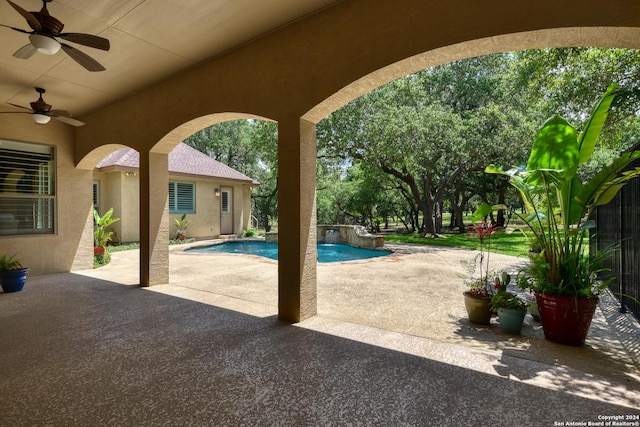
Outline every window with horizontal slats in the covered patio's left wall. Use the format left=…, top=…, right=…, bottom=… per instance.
left=0, top=139, right=56, bottom=236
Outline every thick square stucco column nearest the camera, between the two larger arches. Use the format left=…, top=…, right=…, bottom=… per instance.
left=278, top=117, right=318, bottom=322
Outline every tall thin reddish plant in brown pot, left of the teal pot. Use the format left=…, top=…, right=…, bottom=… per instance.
left=463, top=203, right=500, bottom=325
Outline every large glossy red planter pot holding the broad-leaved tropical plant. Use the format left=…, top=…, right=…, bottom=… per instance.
left=536, top=294, right=598, bottom=346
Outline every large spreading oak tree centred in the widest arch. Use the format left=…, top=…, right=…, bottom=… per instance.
left=318, top=54, right=533, bottom=235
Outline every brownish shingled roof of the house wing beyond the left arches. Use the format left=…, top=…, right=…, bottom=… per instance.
left=96, top=142, right=258, bottom=185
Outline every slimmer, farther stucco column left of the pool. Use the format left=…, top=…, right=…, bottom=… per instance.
left=139, top=151, right=169, bottom=286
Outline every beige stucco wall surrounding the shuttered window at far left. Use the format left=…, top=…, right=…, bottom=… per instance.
left=0, top=114, right=93, bottom=275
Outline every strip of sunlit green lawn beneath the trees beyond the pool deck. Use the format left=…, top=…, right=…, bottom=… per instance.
left=384, top=232, right=529, bottom=256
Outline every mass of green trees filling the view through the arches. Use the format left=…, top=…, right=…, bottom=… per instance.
left=185, top=48, right=640, bottom=236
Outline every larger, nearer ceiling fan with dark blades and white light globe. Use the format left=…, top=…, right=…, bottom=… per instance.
left=0, top=0, right=110, bottom=71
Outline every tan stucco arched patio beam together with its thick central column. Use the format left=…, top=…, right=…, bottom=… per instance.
left=67, top=0, right=640, bottom=321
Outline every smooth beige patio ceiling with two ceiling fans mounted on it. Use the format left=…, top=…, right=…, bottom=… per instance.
left=0, top=0, right=339, bottom=117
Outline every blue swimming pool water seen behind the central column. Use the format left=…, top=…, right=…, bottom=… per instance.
left=188, top=241, right=391, bottom=262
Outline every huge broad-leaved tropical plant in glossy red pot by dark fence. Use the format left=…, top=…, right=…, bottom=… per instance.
left=485, top=85, right=640, bottom=345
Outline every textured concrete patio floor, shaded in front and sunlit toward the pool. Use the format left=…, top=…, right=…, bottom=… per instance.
left=0, top=242, right=640, bottom=426
